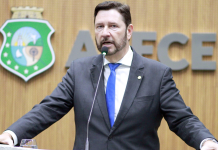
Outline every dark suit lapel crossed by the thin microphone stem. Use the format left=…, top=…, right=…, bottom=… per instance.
left=90, top=55, right=110, bottom=129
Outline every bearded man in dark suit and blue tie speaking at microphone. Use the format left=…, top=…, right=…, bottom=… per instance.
left=0, top=2, right=218, bottom=150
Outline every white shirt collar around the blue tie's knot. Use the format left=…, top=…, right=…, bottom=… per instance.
left=104, top=47, right=133, bottom=66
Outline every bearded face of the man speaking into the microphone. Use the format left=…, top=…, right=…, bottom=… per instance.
left=95, top=9, right=128, bottom=56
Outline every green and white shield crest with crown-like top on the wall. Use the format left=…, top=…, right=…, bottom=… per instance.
left=0, top=7, right=55, bottom=82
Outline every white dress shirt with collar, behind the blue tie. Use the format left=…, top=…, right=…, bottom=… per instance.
left=104, top=47, right=133, bottom=122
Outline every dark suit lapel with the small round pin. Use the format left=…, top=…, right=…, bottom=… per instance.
left=110, top=50, right=144, bottom=134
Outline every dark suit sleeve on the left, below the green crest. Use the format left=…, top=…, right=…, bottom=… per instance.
left=7, top=63, right=74, bottom=143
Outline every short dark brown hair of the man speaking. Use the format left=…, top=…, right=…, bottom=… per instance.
left=94, top=1, right=132, bottom=27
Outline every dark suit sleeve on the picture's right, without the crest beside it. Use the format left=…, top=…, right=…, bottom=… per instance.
left=160, top=68, right=215, bottom=149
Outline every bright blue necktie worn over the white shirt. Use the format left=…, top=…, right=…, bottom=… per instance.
left=106, top=63, right=120, bottom=127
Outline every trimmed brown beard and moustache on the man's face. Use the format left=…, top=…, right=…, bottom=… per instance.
left=95, top=32, right=127, bottom=56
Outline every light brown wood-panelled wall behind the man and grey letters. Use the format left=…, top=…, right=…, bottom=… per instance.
left=0, top=0, right=218, bottom=150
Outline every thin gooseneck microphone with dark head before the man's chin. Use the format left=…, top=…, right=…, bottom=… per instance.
left=85, top=46, right=108, bottom=150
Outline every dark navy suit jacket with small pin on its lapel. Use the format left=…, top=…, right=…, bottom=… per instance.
left=8, top=50, right=214, bottom=150
